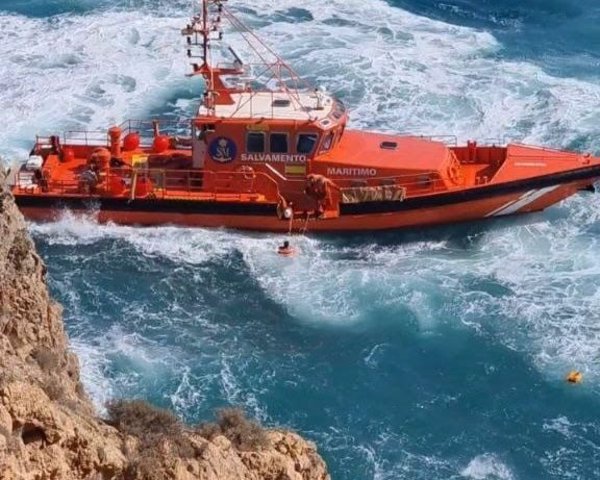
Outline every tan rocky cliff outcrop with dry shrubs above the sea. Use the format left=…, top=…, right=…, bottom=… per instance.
left=0, top=167, right=329, bottom=480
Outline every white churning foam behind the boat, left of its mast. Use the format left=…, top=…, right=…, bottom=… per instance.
left=0, top=7, right=189, bottom=159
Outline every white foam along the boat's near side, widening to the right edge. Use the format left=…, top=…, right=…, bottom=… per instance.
left=31, top=196, right=600, bottom=392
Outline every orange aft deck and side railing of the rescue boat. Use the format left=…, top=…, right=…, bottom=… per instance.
left=13, top=147, right=278, bottom=203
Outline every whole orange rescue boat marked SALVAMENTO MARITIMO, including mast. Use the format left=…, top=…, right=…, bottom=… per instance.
left=4, top=0, right=600, bottom=232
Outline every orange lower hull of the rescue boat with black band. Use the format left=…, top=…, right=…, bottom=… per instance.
left=12, top=166, right=600, bottom=232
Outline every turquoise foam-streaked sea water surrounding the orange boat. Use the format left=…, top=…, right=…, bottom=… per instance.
left=0, top=0, right=600, bottom=480
